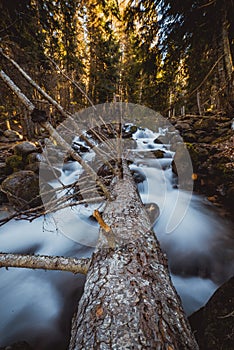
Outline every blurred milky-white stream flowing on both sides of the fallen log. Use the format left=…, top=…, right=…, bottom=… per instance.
left=0, top=124, right=234, bottom=350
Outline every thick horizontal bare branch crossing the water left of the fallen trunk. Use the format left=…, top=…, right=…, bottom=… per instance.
left=0, top=253, right=90, bottom=274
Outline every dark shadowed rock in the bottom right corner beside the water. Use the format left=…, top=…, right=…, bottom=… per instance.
left=189, top=277, right=234, bottom=350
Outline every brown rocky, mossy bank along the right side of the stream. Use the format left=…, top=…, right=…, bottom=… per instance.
left=171, top=114, right=234, bottom=218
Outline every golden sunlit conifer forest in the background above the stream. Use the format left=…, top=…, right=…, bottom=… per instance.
left=0, top=0, right=234, bottom=120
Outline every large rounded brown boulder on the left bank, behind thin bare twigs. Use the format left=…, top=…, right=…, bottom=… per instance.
left=1, top=170, right=51, bottom=210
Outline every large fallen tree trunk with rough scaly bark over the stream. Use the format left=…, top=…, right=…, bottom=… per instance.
left=69, top=164, right=198, bottom=350
